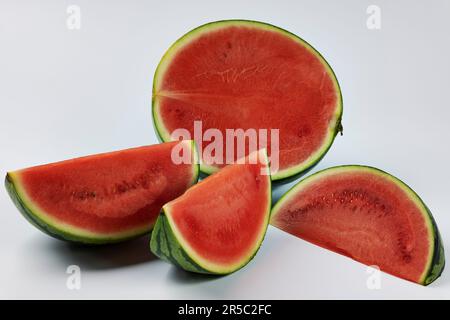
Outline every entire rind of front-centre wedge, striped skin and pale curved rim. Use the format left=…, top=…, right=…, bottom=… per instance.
left=150, top=152, right=272, bottom=275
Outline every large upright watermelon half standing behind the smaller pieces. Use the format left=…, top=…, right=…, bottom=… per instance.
left=152, top=20, right=342, bottom=180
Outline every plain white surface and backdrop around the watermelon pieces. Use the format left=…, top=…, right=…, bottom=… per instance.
left=0, top=0, right=450, bottom=299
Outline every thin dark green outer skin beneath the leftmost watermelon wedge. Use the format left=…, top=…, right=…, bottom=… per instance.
left=5, top=174, right=151, bottom=245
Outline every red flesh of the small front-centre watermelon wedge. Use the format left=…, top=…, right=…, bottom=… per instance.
left=168, top=152, right=270, bottom=264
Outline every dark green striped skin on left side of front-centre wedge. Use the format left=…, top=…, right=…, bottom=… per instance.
left=150, top=212, right=209, bottom=274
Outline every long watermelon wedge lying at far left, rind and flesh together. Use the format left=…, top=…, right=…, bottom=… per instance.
left=5, top=140, right=198, bottom=244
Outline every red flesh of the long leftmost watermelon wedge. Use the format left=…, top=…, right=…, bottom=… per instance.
left=18, top=142, right=194, bottom=233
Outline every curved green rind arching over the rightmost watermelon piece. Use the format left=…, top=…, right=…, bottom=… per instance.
left=271, top=165, right=445, bottom=286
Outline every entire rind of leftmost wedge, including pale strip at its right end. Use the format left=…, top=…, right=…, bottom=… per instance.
left=5, top=141, right=200, bottom=245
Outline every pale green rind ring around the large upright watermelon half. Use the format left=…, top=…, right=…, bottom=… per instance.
left=152, top=19, right=343, bottom=183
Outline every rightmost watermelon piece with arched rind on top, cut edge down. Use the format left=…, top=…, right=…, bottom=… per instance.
left=271, top=166, right=445, bottom=285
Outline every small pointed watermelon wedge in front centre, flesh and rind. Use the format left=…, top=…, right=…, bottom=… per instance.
left=150, top=150, right=272, bottom=274
